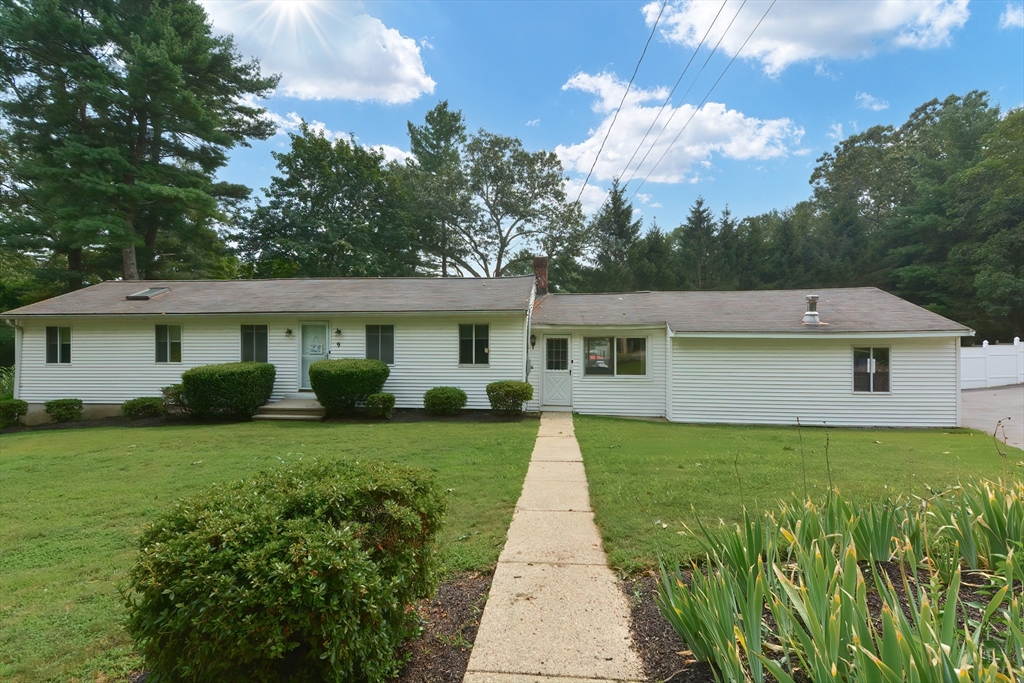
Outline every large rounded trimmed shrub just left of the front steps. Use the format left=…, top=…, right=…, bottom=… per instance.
left=181, top=361, right=276, bottom=418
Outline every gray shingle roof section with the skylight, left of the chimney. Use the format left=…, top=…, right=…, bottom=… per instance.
left=3, top=275, right=534, bottom=317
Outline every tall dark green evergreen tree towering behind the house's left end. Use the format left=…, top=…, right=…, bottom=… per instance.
left=0, top=0, right=276, bottom=288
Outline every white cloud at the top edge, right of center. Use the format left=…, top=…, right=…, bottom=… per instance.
left=643, top=0, right=970, bottom=76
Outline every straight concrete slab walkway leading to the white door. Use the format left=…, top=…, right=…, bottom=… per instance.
left=463, top=413, right=644, bottom=683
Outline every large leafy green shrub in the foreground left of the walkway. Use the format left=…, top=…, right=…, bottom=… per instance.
left=122, top=460, right=445, bottom=683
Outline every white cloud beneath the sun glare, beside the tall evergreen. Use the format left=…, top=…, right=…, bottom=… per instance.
left=203, top=0, right=435, bottom=104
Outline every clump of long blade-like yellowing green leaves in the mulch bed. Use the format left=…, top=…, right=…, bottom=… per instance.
left=658, top=481, right=1024, bottom=683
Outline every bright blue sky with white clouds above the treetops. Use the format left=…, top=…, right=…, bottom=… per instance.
left=203, top=0, right=1024, bottom=228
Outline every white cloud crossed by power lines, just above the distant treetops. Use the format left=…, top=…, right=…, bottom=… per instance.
left=555, top=74, right=804, bottom=183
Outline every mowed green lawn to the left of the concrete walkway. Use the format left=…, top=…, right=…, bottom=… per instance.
left=0, top=419, right=538, bottom=682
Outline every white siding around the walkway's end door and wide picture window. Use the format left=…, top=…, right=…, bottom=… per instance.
left=527, top=328, right=666, bottom=417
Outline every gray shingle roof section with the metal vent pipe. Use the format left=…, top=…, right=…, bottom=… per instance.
left=534, top=287, right=971, bottom=334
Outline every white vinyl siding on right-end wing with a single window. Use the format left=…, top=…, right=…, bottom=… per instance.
left=672, top=337, right=959, bottom=427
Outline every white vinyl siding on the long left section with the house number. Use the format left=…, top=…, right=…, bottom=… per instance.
left=18, top=312, right=526, bottom=409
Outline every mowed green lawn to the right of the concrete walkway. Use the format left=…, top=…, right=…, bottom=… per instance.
left=575, top=416, right=1024, bottom=572
